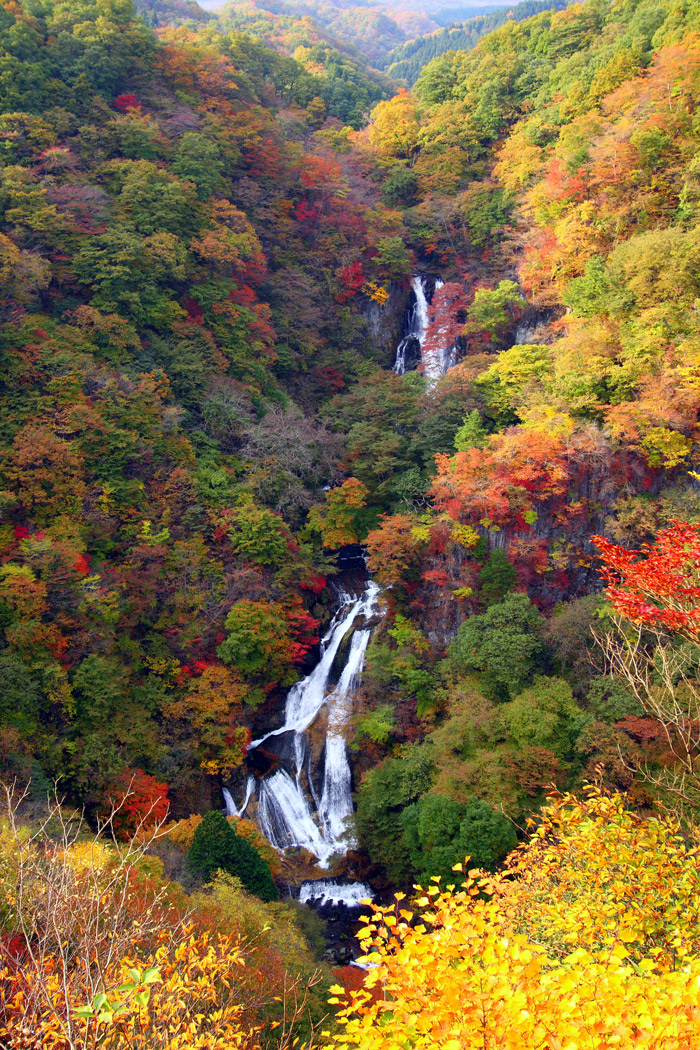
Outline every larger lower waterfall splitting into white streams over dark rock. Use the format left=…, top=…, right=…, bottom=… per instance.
left=232, top=581, right=379, bottom=867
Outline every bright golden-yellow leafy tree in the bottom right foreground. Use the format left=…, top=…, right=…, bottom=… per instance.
left=327, top=789, right=700, bottom=1050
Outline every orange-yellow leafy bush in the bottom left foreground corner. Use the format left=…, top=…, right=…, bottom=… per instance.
left=0, top=930, right=257, bottom=1050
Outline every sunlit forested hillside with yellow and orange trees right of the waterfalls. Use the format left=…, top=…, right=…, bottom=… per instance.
left=345, top=2, right=700, bottom=882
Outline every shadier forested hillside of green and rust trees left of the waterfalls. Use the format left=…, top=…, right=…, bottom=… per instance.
left=0, top=3, right=409, bottom=815
